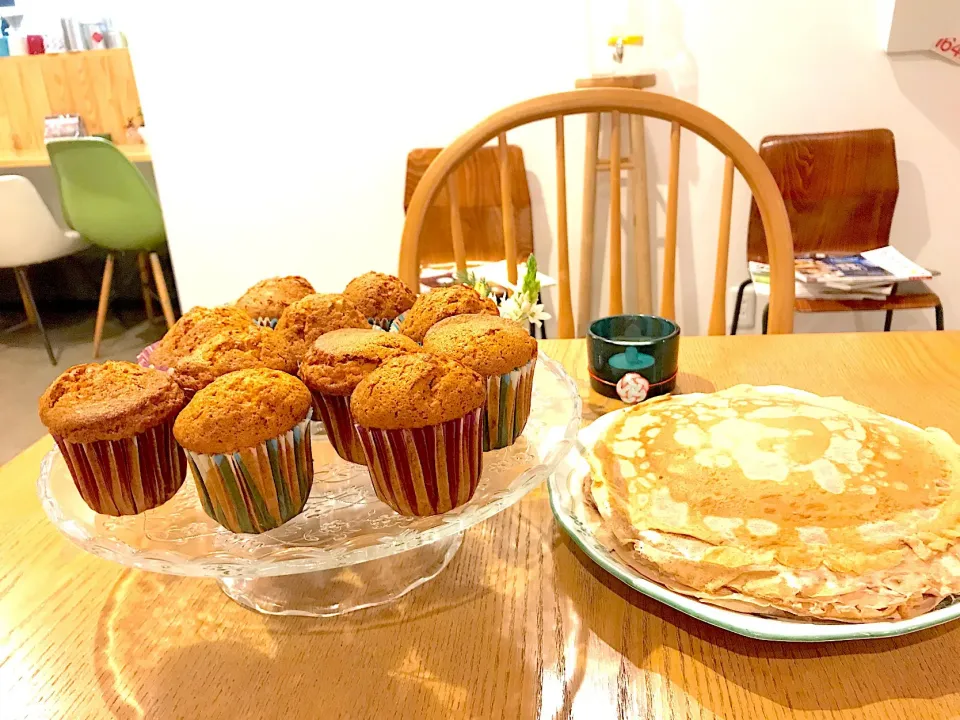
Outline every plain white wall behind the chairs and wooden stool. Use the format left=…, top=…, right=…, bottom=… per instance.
left=127, top=0, right=960, bottom=334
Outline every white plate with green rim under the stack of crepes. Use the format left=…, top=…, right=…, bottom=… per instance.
left=548, top=387, right=960, bottom=642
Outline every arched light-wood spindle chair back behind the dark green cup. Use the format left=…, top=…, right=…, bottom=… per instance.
left=400, top=88, right=794, bottom=337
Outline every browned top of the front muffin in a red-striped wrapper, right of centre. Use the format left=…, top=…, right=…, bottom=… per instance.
left=350, top=352, right=486, bottom=430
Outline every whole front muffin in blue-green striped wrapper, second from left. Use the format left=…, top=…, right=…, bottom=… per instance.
left=173, top=368, right=313, bottom=533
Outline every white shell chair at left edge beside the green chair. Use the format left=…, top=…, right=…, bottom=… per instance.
left=0, top=175, right=90, bottom=365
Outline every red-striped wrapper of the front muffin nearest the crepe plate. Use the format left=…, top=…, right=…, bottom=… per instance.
left=356, top=408, right=483, bottom=516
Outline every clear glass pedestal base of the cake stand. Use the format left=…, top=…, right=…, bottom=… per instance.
left=217, top=533, right=463, bottom=617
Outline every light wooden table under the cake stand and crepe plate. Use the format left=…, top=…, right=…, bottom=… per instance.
left=0, top=332, right=960, bottom=720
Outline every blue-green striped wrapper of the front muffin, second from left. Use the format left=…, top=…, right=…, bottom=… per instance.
left=187, top=413, right=313, bottom=533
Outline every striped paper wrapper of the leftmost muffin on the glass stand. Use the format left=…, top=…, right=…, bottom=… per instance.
left=53, top=420, right=187, bottom=516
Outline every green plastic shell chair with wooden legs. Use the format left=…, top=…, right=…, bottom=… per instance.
left=47, top=137, right=174, bottom=357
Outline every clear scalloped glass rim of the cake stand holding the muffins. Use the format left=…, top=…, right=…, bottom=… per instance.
left=37, top=351, right=582, bottom=577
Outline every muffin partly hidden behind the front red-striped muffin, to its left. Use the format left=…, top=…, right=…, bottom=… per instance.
left=300, top=326, right=420, bottom=465
